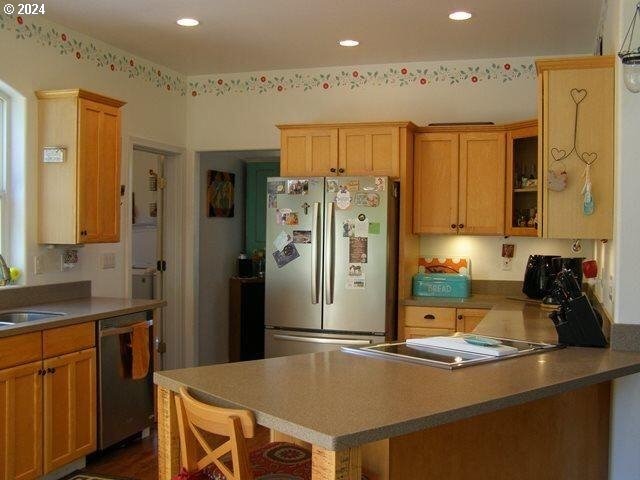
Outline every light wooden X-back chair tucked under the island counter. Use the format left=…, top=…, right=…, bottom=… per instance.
left=174, top=387, right=374, bottom=480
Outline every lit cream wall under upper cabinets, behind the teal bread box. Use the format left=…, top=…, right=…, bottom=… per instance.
left=416, top=235, right=593, bottom=281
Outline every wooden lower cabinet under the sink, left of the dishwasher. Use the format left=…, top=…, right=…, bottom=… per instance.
left=0, top=323, right=97, bottom=480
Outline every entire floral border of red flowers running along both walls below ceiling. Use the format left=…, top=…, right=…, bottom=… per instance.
left=0, top=13, right=536, bottom=97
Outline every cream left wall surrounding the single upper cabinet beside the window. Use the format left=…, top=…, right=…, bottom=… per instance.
left=0, top=15, right=186, bottom=296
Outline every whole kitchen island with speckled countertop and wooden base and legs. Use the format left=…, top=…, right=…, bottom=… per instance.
left=155, top=302, right=640, bottom=480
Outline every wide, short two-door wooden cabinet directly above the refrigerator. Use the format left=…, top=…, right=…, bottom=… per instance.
left=278, top=122, right=413, bottom=178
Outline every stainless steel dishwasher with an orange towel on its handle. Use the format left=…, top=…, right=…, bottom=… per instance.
left=97, top=311, right=154, bottom=450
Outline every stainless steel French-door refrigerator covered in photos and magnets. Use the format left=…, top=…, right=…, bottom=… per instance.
left=265, top=177, right=398, bottom=357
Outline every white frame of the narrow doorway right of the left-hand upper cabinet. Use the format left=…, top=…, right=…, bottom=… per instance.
left=122, top=136, right=197, bottom=368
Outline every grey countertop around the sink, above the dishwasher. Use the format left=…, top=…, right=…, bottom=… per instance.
left=0, top=297, right=167, bottom=338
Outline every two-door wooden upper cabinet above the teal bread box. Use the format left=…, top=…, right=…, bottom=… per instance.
left=413, top=132, right=505, bottom=235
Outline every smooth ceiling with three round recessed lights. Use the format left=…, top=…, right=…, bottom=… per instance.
left=47, top=0, right=603, bottom=75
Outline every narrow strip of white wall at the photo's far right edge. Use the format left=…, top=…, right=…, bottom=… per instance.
left=605, top=0, right=640, bottom=480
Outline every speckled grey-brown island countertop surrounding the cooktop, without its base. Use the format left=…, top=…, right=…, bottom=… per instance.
left=154, top=297, right=640, bottom=450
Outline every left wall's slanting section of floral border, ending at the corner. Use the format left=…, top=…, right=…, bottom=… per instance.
left=0, top=13, right=187, bottom=95
